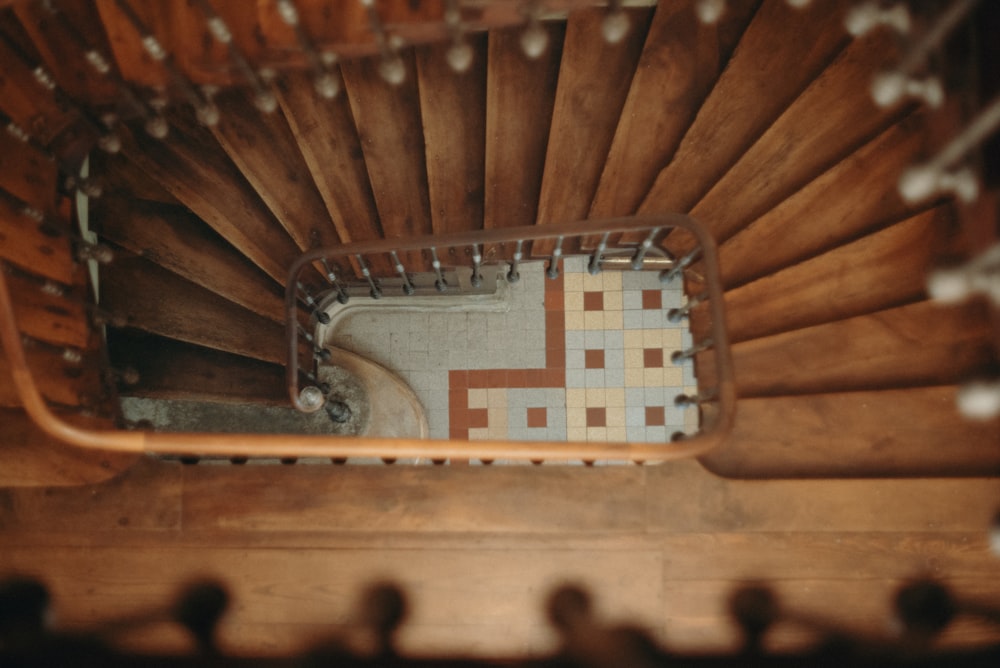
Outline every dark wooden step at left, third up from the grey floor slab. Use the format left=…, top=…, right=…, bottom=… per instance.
left=91, top=195, right=285, bottom=322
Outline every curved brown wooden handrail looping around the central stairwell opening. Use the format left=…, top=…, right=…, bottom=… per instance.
left=0, top=214, right=736, bottom=463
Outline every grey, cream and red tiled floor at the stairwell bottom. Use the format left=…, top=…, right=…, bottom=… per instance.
left=327, top=258, right=697, bottom=442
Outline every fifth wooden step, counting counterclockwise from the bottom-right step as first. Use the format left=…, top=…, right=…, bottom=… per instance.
left=677, top=33, right=905, bottom=252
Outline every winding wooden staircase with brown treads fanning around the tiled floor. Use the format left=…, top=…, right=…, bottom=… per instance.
left=0, top=0, right=1000, bottom=484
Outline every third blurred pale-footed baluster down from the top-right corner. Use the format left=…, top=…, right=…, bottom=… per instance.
left=899, top=97, right=1000, bottom=204
